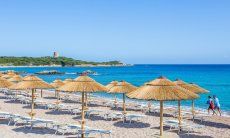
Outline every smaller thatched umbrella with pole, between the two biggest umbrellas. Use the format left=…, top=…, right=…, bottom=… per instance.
left=109, top=81, right=137, bottom=115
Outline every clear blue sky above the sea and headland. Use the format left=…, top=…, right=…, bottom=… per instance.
left=0, top=0, right=230, bottom=64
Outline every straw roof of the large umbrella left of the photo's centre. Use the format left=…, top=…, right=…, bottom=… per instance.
left=57, top=76, right=107, bottom=92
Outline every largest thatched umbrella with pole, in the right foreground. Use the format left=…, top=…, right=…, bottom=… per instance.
left=127, top=77, right=198, bottom=136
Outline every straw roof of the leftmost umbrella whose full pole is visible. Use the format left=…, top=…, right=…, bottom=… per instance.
left=10, top=75, right=53, bottom=89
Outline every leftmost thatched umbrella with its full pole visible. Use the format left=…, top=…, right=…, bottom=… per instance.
left=10, top=75, right=53, bottom=119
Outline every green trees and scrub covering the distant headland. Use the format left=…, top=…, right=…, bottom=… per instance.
left=0, top=56, right=123, bottom=66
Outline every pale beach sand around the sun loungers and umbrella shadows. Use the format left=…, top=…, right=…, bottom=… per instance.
left=0, top=91, right=230, bottom=138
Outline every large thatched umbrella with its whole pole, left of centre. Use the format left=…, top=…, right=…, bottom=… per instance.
left=57, top=76, right=107, bottom=137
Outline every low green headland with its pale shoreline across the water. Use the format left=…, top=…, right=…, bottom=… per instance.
left=0, top=56, right=131, bottom=68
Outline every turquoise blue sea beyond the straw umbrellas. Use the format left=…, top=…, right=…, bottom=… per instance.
left=0, top=65, right=230, bottom=114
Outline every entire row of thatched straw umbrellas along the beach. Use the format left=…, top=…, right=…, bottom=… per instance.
left=0, top=73, right=208, bottom=137
